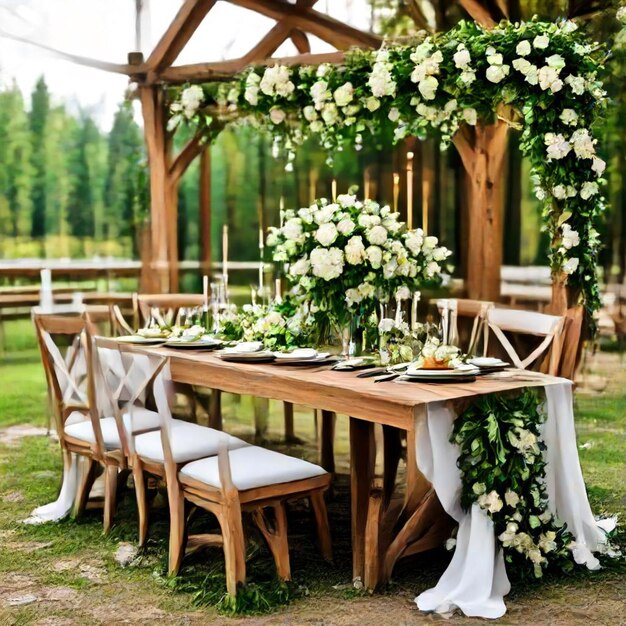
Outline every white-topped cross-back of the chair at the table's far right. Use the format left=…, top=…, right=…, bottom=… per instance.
left=487, top=307, right=565, bottom=376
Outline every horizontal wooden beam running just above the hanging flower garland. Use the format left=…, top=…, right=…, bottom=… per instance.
left=158, top=51, right=345, bottom=85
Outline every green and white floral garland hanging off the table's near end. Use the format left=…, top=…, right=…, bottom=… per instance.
left=450, top=389, right=574, bottom=578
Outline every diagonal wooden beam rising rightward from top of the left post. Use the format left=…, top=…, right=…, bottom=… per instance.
left=146, top=0, right=217, bottom=74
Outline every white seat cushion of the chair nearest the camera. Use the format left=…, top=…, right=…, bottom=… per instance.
left=178, top=446, right=326, bottom=491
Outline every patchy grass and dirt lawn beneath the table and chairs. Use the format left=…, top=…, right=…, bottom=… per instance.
left=0, top=323, right=626, bottom=626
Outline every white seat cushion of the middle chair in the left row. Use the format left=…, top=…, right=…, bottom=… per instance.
left=135, top=420, right=248, bottom=463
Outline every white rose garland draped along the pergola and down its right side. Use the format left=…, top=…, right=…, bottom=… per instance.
left=170, top=20, right=606, bottom=322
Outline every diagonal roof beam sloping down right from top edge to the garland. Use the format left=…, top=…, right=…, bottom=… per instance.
left=228, top=0, right=382, bottom=50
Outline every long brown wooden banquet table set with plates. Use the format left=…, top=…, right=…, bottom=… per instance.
left=124, top=346, right=554, bottom=589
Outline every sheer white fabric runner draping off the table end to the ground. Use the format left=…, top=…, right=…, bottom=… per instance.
left=415, top=379, right=601, bottom=619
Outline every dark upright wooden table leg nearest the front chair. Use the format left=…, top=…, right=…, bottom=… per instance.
left=350, top=417, right=377, bottom=581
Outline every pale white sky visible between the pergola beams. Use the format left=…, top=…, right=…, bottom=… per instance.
left=0, top=0, right=369, bottom=130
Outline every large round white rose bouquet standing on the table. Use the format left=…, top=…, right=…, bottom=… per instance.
left=267, top=194, right=451, bottom=329
